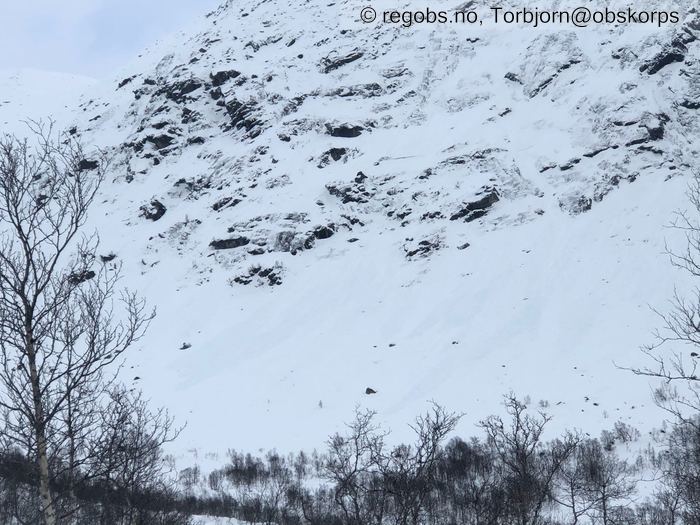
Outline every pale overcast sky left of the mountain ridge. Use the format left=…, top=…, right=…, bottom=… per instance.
left=0, top=0, right=221, bottom=78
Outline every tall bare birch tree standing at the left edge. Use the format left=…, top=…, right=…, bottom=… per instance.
left=0, top=124, right=153, bottom=525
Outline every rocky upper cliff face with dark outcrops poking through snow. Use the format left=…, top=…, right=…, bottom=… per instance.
left=80, top=2, right=700, bottom=285
